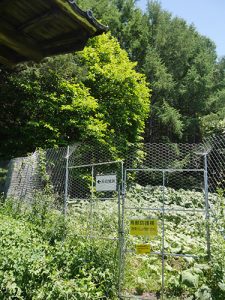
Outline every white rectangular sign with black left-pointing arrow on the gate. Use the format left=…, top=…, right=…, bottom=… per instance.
left=96, top=174, right=117, bottom=192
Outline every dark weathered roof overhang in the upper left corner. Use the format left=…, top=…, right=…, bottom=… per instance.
left=0, top=0, right=107, bottom=65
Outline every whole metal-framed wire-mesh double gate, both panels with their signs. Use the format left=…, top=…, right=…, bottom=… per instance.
left=64, top=145, right=210, bottom=299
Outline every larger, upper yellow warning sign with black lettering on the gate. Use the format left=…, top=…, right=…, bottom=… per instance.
left=130, top=219, right=158, bottom=237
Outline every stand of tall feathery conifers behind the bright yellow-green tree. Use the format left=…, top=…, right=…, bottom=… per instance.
left=79, top=0, right=221, bottom=142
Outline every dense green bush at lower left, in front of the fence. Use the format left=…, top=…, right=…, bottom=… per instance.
left=0, top=197, right=116, bottom=300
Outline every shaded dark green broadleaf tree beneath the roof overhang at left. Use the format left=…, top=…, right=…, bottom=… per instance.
left=0, top=58, right=106, bottom=155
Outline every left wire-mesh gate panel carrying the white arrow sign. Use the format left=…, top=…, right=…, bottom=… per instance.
left=67, top=161, right=123, bottom=240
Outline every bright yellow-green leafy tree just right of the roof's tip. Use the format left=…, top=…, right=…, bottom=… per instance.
left=76, top=34, right=150, bottom=155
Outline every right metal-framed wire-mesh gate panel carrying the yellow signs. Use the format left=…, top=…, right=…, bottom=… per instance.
left=120, top=169, right=210, bottom=299
